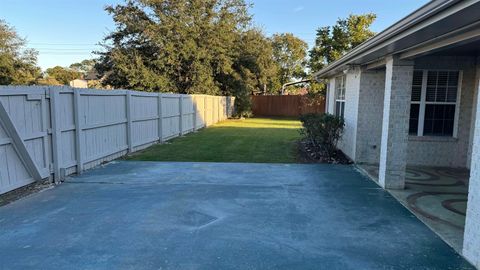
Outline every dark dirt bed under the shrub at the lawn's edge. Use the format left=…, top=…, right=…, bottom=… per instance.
left=297, top=140, right=353, bottom=164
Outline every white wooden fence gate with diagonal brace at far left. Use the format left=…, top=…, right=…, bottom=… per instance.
left=0, top=88, right=51, bottom=194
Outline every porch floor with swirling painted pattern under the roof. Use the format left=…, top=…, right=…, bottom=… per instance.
left=359, top=165, right=469, bottom=253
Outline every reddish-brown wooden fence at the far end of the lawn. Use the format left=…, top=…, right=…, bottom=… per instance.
left=251, top=95, right=325, bottom=116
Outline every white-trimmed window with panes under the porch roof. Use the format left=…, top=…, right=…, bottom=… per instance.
left=409, top=70, right=461, bottom=137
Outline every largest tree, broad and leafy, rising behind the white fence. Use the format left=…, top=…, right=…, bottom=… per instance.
left=97, top=0, right=250, bottom=94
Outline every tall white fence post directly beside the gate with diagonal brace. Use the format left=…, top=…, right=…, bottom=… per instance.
left=49, top=88, right=63, bottom=183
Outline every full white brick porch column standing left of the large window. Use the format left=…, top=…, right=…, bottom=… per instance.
left=379, top=56, right=413, bottom=189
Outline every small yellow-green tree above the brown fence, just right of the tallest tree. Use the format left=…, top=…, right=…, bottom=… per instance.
left=272, top=33, right=308, bottom=85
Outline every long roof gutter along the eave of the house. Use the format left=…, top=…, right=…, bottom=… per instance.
left=313, top=0, right=464, bottom=79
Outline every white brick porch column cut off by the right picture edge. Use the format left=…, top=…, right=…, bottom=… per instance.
left=463, top=63, right=480, bottom=268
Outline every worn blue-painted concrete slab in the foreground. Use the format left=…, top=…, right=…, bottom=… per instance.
left=0, top=161, right=471, bottom=270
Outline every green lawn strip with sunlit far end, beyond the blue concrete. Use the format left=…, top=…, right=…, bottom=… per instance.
left=127, top=118, right=301, bottom=163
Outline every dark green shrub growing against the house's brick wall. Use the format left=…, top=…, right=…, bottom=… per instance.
left=300, top=113, right=345, bottom=157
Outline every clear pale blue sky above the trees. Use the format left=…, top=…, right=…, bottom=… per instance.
left=0, top=0, right=428, bottom=69
